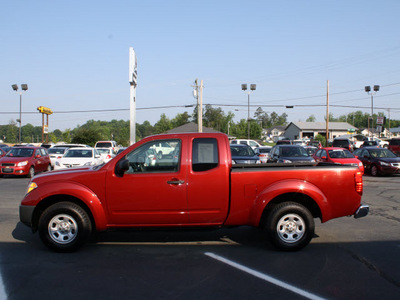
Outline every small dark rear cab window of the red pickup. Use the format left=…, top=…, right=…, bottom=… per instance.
left=192, top=138, right=219, bottom=172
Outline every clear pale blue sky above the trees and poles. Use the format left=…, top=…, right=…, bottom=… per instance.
left=0, top=0, right=400, bottom=131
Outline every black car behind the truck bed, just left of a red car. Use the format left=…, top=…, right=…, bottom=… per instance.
left=268, top=145, right=315, bottom=163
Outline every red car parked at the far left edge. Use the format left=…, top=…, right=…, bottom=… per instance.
left=0, top=146, right=51, bottom=178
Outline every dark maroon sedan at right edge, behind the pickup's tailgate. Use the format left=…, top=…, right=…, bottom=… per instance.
left=354, top=147, right=400, bottom=176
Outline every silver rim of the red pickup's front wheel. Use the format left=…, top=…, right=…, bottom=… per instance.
left=48, top=214, right=78, bottom=244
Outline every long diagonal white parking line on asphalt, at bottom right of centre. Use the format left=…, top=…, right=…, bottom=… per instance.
left=204, top=252, right=325, bottom=300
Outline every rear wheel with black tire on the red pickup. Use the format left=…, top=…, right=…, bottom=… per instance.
left=264, top=202, right=315, bottom=251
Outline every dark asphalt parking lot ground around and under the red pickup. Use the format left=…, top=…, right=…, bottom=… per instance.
left=0, top=175, right=400, bottom=299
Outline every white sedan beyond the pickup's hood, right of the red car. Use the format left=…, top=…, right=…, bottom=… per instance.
left=54, top=148, right=104, bottom=170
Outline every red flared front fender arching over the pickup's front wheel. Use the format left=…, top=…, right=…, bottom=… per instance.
left=21, top=182, right=107, bottom=230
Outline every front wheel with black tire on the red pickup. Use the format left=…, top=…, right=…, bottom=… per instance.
left=39, top=202, right=92, bottom=252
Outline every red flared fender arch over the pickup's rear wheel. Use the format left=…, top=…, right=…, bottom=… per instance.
left=249, top=179, right=331, bottom=225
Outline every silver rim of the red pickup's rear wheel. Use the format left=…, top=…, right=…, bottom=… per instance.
left=276, top=214, right=306, bottom=244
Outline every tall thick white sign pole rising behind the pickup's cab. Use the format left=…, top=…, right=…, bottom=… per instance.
left=129, top=47, right=137, bottom=145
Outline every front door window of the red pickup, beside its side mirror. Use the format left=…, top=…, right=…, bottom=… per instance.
left=125, top=140, right=181, bottom=174
